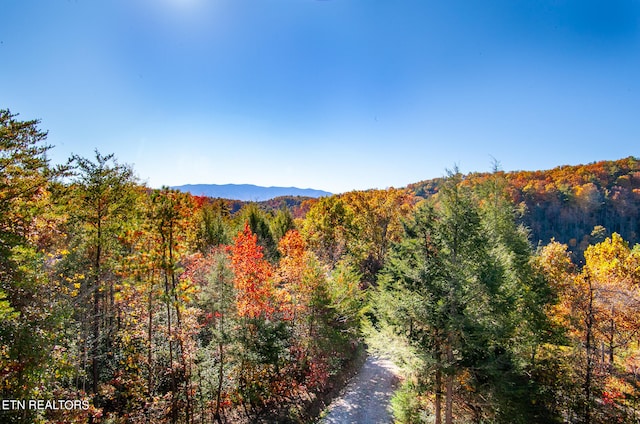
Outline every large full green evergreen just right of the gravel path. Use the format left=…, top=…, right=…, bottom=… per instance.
left=374, top=173, right=547, bottom=423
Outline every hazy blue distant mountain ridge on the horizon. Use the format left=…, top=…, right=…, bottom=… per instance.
left=171, top=184, right=331, bottom=202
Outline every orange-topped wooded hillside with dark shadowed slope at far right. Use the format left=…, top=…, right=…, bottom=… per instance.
left=407, top=157, right=640, bottom=260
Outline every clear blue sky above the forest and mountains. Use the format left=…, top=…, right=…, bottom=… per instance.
left=0, top=0, right=640, bottom=192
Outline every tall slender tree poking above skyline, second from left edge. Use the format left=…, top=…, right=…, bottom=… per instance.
left=67, top=150, right=135, bottom=394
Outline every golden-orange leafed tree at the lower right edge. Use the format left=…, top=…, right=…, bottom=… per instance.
left=539, top=233, right=640, bottom=423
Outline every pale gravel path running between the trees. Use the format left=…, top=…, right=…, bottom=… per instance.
left=320, top=356, right=398, bottom=424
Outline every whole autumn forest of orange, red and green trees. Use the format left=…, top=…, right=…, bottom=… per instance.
left=0, top=110, right=640, bottom=424
